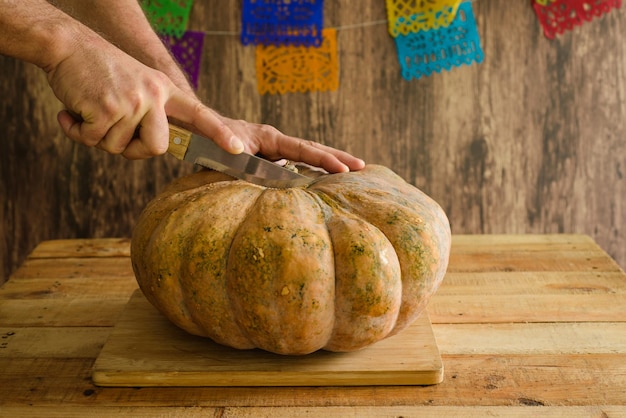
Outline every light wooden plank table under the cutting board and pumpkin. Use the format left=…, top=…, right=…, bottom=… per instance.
left=0, top=235, right=626, bottom=417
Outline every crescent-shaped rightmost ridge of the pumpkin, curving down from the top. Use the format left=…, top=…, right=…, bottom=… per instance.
left=310, top=165, right=450, bottom=336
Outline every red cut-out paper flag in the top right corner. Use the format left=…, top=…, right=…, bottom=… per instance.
left=533, top=0, right=622, bottom=39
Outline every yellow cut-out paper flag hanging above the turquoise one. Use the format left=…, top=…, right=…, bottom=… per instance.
left=386, top=0, right=461, bottom=38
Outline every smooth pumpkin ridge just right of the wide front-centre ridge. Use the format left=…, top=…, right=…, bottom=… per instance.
left=310, top=190, right=402, bottom=351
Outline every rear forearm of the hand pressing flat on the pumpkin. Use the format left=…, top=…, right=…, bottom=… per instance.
left=52, top=0, right=193, bottom=93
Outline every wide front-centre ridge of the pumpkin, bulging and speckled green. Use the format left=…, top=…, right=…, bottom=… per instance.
left=228, top=188, right=334, bottom=354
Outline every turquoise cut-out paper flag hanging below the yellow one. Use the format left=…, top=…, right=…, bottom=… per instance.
left=396, top=2, right=484, bottom=80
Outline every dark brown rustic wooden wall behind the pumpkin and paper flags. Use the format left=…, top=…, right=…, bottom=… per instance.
left=0, top=0, right=626, bottom=282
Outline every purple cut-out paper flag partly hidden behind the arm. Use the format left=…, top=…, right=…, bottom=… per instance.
left=161, top=31, right=204, bottom=89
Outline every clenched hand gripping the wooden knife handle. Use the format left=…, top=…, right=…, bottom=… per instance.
left=44, top=31, right=195, bottom=159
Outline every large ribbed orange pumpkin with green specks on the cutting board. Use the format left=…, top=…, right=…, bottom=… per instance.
left=131, top=165, right=451, bottom=355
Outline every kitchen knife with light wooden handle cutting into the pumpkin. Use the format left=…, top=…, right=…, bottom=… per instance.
left=167, top=124, right=314, bottom=189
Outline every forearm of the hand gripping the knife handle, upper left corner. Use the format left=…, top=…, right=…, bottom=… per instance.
left=0, top=0, right=89, bottom=71
